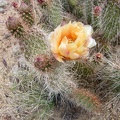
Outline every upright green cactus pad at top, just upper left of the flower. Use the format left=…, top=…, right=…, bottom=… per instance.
left=38, top=0, right=63, bottom=30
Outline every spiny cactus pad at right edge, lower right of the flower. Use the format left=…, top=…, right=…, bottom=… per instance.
left=97, top=56, right=120, bottom=96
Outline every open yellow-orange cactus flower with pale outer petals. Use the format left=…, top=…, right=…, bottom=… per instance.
left=49, top=22, right=96, bottom=62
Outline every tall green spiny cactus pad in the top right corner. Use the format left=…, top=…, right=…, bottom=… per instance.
left=101, top=2, right=120, bottom=43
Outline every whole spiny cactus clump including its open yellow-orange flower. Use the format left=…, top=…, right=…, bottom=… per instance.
left=4, top=0, right=120, bottom=120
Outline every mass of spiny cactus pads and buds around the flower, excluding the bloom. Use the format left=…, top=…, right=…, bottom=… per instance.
left=6, top=0, right=120, bottom=120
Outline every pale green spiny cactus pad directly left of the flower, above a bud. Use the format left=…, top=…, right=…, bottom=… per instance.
left=21, top=33, right=47, bottom=61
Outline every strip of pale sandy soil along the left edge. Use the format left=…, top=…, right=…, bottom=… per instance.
left=0, top=0, right=23, bottom=120
